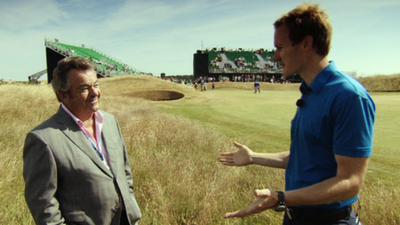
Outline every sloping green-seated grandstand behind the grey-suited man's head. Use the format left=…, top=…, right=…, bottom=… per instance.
left=45, top=39, right=139, bottom=83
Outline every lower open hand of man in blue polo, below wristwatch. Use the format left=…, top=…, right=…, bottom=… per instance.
left=224, top=189, right=278, bottom=219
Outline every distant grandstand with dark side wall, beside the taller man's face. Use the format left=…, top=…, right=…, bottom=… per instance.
left=193, top=48, right=301, bottom=82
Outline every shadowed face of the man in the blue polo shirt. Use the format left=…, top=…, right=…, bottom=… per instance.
left=273, top=25, right=304, bottom=77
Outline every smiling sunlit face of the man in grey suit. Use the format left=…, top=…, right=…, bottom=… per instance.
left=62, top=69, right=101, bottom=120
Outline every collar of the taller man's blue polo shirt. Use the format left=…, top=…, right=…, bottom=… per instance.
left=300, top=61, right=338, bottom=93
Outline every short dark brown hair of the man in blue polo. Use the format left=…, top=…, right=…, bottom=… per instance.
left=274, top=2, right=332, bottom=56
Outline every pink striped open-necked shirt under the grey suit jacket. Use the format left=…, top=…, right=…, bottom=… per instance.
left=61, top=104, right=109, bottom=168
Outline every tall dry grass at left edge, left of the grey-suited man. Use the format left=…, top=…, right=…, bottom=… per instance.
left=0, top=85, right=58, bottom=224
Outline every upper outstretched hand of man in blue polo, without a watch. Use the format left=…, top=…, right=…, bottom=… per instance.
left=218, top=141, right=254, bottom=166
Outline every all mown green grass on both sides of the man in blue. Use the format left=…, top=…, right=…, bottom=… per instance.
left=158, top=89, right=400, bottom=187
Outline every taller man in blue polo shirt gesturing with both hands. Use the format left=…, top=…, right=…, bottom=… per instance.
left=219, top=3, right=375, bottom=225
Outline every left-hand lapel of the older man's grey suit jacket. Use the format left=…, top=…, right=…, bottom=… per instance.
left=56, top=107, right=113, bottom=177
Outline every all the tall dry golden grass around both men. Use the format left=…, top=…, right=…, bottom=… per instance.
left=0, top=77, right=400, bottom=225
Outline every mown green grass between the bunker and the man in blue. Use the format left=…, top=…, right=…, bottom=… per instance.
left=158, top=90, right=299, bottom=152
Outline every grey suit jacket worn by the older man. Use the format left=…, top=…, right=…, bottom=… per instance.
left=23, top=107, right=141, bottom=225
